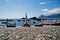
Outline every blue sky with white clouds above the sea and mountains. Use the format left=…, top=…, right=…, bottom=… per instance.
left=0, top=0, right=60, bottom=18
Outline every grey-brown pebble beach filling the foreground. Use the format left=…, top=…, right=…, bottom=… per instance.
left=0, top=27, right=60, bottom=40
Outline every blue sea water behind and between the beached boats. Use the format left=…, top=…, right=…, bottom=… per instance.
left=0, top=19, right=40, bottom=26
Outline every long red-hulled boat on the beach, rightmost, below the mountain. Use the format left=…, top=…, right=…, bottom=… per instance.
left=35, top=19, right=60, bottom=27
